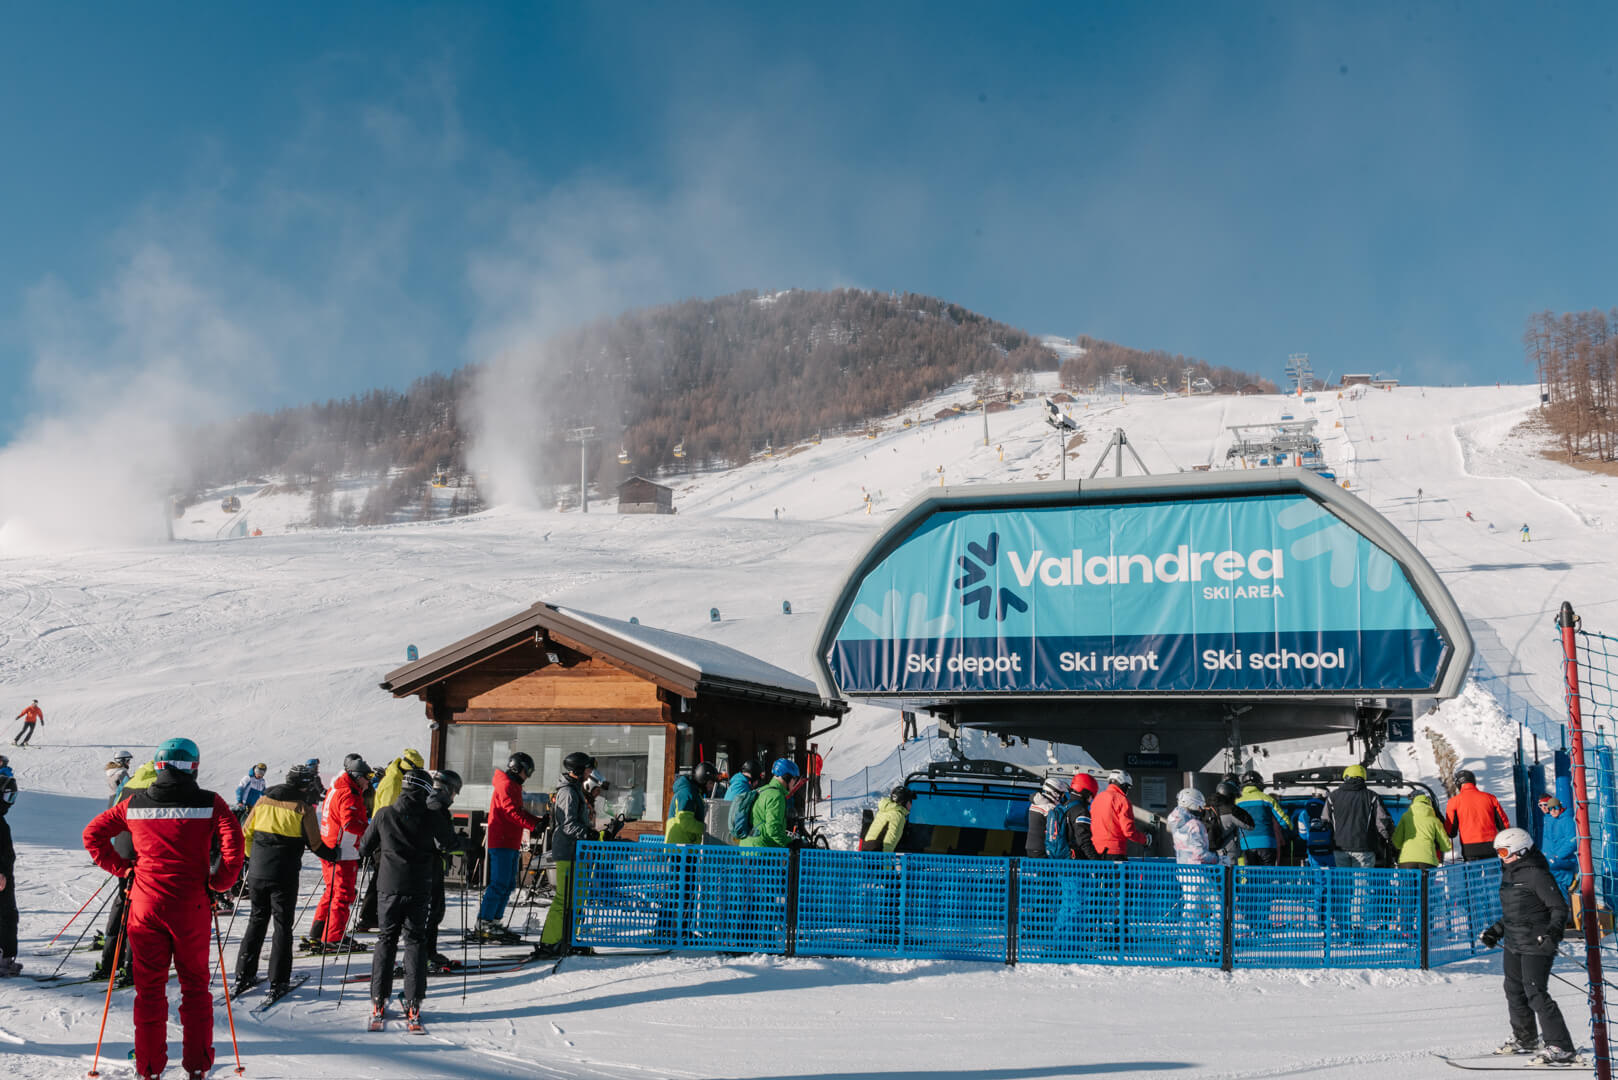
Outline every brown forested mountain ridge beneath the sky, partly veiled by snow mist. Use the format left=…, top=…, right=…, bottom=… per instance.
left=173, top=290, right=1252, bottom=525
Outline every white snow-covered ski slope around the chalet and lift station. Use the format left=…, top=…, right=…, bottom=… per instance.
left=0, top=375, right=1598, bottom=1080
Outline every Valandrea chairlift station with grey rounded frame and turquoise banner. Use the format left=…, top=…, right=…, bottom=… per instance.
left=814, top=468, right=1472, bottom=813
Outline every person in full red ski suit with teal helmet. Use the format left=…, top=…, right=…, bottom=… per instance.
left=84, top=738, right=241, bottom=1080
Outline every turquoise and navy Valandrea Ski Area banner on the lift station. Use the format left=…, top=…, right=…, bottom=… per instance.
left=822, top=470, right=1469, bottom=696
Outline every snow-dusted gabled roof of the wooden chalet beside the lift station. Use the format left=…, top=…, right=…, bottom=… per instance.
left=380, top=601, right=848, bottom=716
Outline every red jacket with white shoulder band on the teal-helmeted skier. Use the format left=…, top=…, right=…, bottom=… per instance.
left=84, top=769, right=241, bottom=912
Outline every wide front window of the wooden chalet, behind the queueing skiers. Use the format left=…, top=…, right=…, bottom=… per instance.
left=443, top=724, right=668, bottom=821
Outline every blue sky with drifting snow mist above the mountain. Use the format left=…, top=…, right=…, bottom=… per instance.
left=0, top=3, right=1618, bottom=442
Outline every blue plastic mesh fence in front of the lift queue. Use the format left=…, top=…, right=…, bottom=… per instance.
left=573, top=844, right=1500, bottom=968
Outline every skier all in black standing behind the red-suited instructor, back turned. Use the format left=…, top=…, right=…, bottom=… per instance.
left=359, top=769, right=458, bottom=1023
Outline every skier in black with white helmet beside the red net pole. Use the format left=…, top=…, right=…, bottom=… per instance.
left=1482, top=829, right=1578, bottom=1065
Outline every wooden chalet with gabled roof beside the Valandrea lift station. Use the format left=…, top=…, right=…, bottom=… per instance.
left=372, top=602, right=848, bottom=836
